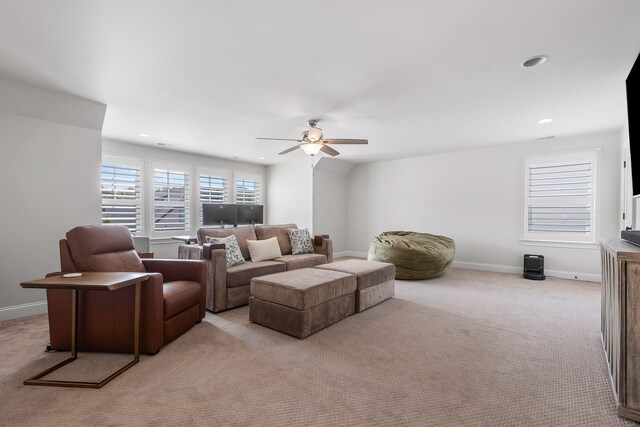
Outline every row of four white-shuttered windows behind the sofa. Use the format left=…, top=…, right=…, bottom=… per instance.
left=100, top=157, right=263, bottom=239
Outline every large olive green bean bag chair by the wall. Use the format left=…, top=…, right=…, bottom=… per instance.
left=367, top=231, right=456, bottom=280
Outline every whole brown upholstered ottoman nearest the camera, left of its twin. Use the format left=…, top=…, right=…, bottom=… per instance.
left=249, top=268, right=357, bottom=338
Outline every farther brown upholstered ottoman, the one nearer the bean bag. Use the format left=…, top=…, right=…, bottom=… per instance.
left=315, top=259, right=396, bottom=313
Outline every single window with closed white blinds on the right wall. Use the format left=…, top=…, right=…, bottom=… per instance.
left=524, top=150, right=598, bottom=243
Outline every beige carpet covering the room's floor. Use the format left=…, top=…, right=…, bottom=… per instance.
left=0, top=269, right=626, bottom=426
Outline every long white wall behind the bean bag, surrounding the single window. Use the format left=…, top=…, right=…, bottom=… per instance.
left=348, top=132, right=621, bottom=281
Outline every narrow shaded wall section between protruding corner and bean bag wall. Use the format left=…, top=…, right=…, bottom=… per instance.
left=313, top=157, right=353, bottom=257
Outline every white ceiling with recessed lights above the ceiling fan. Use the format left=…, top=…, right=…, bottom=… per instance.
left=0, top=0, right=640, bottom=164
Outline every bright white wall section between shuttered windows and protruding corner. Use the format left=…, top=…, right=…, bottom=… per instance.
left=265, top=159, right=314, bottom=234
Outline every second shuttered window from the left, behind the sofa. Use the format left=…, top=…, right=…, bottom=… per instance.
left=153, top=169, right=190, bottom=231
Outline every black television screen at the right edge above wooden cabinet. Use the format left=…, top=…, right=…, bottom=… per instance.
left=627, top=50, right=640, bottom=196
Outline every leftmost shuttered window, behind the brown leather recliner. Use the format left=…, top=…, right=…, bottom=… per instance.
left=100, top=162, right=142, bottom=234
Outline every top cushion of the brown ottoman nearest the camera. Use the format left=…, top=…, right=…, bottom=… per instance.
left=251, top=268, right=356, bottom=310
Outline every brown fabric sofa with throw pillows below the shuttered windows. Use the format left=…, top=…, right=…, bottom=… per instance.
left=178, top=224, right=333, bottom=313
